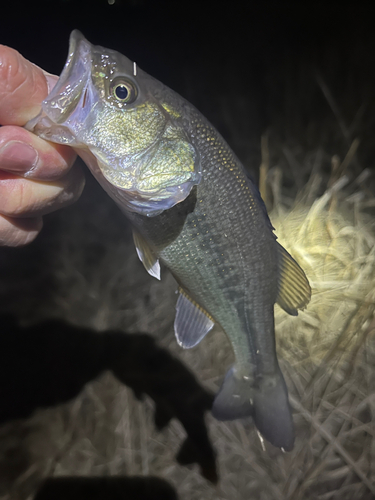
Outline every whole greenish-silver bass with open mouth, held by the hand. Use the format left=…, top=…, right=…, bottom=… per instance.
left=27, top=30, right=311, bottom=450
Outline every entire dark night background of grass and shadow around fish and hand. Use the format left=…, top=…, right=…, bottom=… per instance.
left=0, top=0, right=375, bottom=500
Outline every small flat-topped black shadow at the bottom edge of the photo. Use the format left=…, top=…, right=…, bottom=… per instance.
left=34, top=477, right=178, bottom=500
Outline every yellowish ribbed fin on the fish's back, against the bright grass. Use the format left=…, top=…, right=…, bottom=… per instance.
left=276, top=243, right=311, bottom=316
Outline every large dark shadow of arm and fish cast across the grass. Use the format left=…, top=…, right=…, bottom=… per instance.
left=0, top=316, right=218, bottom=483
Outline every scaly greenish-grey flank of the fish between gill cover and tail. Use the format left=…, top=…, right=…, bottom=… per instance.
left=134, top=111, right=277, bottom=375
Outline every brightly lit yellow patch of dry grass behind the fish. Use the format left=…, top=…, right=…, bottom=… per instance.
left=271, top=179, right=375, bottom=359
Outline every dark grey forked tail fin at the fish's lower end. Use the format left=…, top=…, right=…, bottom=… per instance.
left=212, top=368, right=294, bottom=451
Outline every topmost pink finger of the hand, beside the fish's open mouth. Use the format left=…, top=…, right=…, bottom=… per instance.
left=0, top=45, right=48, bottom=126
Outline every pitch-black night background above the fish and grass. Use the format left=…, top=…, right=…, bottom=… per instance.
left=0, top=0, right=375, bottom=169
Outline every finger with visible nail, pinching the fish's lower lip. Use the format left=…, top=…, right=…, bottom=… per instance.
left=0, top=126, right=76, bottom=181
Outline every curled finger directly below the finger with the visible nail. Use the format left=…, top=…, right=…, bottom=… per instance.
left=0, top=165, right=85, bottom=217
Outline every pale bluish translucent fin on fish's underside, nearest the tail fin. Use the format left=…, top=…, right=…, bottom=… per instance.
left=174, top=288, right=214, bottom=349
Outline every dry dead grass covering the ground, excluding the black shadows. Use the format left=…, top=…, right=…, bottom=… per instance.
left=0, top=35, right=375, bottom=500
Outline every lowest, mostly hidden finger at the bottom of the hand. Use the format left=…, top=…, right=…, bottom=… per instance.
left=0, top=215, right=43, bottom=247
